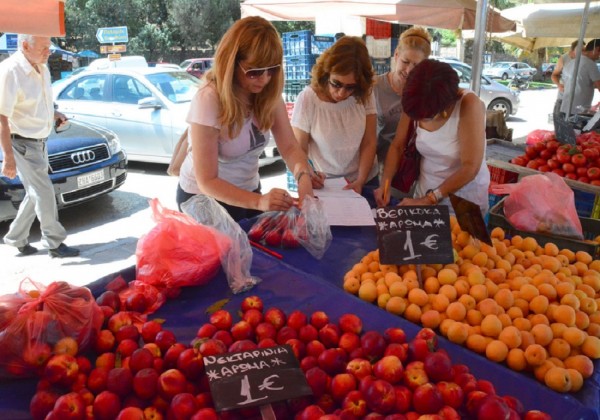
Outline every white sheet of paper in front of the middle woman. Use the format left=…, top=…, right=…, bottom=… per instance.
left=319, top=195, right=375, bottom=226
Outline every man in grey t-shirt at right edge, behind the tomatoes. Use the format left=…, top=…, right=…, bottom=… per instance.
left=560, top=38, right=600, bottom=115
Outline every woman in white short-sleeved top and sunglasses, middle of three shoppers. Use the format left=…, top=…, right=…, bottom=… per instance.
left=292, top=36, right=377, bottom=196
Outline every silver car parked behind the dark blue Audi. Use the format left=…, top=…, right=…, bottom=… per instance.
left=53, top=67, right=281, bottom=166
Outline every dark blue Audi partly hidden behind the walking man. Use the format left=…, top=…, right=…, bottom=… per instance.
left=0, top=121, right=127, bottom=222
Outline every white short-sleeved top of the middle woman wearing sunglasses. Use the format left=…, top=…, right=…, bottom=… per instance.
left=292, top=86, right=377, bottom=182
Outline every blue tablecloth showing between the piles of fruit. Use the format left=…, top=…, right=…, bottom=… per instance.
left=0, top=228, right=600, bottom=420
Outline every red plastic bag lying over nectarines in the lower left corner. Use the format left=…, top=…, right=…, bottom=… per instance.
left=0, top=279, right=104, bottom=377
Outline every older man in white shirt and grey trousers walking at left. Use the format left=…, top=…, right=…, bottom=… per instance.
left=0, top=35, right=79, bottom=258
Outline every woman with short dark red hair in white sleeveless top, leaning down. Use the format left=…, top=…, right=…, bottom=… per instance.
left=375, top=60, right=490, bottom=214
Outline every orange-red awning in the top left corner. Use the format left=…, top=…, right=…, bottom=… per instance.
left=0, top=0, right=65, bottom=36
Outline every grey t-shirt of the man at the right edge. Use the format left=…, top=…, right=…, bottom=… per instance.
left=560, top=55, right=600, bottom=114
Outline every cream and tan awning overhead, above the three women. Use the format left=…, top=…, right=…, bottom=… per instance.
left=241, top=0, right=515, bottom=32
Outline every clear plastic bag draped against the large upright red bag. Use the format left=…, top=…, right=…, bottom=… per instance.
left=181, top=195, right=260, bottom=293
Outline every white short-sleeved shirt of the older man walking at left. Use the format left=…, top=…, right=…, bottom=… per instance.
left=0, top=51, right=54, bottom=139
